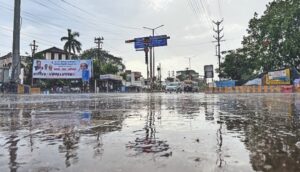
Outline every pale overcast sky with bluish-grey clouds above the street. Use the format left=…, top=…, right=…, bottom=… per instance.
left=0, top=0, right=271, bottom=77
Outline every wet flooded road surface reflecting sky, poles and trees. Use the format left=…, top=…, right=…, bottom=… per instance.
left=0, top=94, right=300, bottom=172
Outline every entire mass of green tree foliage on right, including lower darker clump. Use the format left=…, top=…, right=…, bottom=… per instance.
left=221, top=0, right=300, bottom=80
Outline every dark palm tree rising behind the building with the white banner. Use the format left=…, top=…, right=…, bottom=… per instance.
left=61, top=29, right=81, bottom=57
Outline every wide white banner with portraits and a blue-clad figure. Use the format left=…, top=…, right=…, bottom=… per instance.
left=32, top=60, right=92, bottom=81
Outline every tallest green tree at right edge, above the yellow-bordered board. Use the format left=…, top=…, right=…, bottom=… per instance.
left=243, top=0, right=300, bottom=71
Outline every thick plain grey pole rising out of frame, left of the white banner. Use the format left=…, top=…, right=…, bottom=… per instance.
left=11, top=0, right=21, bottom=83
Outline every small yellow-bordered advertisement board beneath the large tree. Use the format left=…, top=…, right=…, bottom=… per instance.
left=266, top=69, right=291, bottom=85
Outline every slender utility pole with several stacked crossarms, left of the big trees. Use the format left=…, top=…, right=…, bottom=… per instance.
left=213, top=19, right=224, bottom=80
